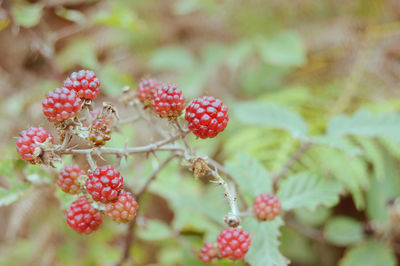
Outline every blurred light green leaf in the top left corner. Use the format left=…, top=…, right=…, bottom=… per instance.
left=11, top=2, right=43, bottom=28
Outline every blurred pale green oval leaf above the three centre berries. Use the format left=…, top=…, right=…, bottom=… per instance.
left=149, top=46, right=196, bottom=71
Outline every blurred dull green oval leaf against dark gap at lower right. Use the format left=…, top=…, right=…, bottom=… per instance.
left=324, top=216, right=364, bottom=246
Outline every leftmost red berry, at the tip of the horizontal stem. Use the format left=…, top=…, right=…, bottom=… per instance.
left=17, top=127, right=54, bottom=164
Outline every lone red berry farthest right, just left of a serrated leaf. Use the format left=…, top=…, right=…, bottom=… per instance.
left=253, top=194, right=281, bottom=221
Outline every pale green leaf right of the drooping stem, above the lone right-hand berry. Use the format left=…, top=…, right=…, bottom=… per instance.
left=226, top=152, right=272, bottom=202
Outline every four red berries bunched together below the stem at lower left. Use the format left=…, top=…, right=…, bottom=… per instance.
left=57, top=165, right=139, bottom=234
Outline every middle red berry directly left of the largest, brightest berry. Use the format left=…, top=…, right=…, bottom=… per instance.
left=151, top=85, right=185, bottom=117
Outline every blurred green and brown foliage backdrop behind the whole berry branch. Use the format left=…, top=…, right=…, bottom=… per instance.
left=0, top=0, right=400, bottom=266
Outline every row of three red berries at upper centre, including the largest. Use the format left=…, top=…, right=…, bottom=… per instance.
left=137, top=79, right=229, bottom=139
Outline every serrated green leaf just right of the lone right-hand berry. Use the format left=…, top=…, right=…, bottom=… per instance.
left=277, top=172, right=342, bottom=210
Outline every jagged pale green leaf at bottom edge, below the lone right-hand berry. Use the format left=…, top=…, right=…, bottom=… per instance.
left=243, top=217, right=289, bottom=266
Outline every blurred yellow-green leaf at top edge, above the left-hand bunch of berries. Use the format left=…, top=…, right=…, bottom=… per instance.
left=93, top=3, right=138, bottom=32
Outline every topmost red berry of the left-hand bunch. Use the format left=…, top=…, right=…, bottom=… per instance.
left=64, top=70, right=100, bottom=100
